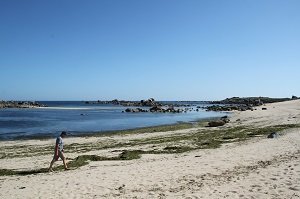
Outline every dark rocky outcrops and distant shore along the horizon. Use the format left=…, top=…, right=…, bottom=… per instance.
left=0, top=96, right=299, bottom=110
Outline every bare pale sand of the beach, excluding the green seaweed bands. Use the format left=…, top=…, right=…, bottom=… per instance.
left=0, top=100, right=300, bottom=199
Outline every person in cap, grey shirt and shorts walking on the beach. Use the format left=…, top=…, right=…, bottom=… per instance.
left=49, top=131, right=68, bottom=172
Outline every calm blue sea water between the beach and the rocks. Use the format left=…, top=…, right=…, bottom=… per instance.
left=0, top=101, right=226, bottom=140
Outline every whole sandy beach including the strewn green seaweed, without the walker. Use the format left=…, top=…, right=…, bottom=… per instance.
left=0, top=100, right=300, bottom=198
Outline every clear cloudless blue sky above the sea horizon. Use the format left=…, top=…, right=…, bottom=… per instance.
left=0, top=0, right=300, bottom=100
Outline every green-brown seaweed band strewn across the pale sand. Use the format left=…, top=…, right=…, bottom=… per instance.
left=0, top=124, right=300, bottom=176
